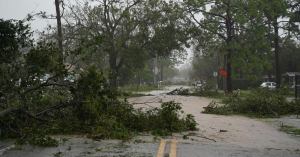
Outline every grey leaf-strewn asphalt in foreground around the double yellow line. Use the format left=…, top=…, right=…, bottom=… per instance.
left=2, top=136, right=300, bottom=157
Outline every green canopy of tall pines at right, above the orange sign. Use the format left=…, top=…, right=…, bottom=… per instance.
left=183, top=0, right=299, bottom=87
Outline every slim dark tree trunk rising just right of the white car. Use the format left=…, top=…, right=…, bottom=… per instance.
left=273, top=18, right=281, bottom=89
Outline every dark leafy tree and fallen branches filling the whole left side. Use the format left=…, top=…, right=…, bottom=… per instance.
left=0, top=19, right=196, bottom=146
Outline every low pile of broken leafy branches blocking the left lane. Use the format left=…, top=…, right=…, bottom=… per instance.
left=0, top=68, right=196, bottom=146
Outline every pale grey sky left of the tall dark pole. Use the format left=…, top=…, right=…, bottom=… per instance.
left=0, top=0, right=56, bottom=30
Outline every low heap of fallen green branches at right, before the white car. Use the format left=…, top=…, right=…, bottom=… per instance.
left=204, top=89, right=297, bottom=117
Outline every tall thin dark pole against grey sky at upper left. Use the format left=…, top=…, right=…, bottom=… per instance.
left=55, top=0, right=64, bottom=64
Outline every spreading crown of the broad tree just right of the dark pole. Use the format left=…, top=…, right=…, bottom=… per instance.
left=65, top=0, right=188, bottom=87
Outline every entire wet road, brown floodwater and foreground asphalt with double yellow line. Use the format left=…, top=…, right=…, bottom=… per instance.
left=2, top=86, right=300, bottom=157
